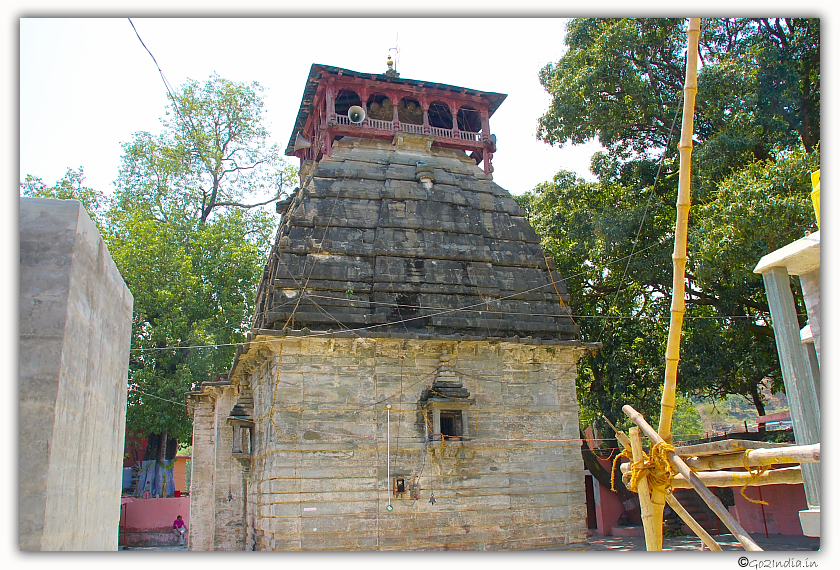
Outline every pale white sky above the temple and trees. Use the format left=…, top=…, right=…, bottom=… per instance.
left=19, top=17, right=599, bottom=194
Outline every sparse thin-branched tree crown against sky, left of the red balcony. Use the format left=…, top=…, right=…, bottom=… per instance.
left=117, top=75, right=297, bottom=224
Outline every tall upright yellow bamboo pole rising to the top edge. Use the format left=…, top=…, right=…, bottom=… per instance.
left=659, top=18, right=700, bottom=443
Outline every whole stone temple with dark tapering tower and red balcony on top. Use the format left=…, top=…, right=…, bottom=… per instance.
left=187, top=62, right=592, bottom=550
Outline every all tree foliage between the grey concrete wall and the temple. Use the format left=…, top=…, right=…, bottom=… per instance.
left=21, top=76, right=297, bottom=449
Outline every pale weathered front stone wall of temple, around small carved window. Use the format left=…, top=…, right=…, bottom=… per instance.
left=238, top=337, right=586, bottom=550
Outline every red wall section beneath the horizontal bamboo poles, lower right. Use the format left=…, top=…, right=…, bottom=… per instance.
left=730, top=483, right=808, bottom=536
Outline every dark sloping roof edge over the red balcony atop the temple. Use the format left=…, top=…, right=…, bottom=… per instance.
left=286, top=63, right=507, bottom=156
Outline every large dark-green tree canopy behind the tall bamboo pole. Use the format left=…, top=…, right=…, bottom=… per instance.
left=520, top=18, right=820, bottom=430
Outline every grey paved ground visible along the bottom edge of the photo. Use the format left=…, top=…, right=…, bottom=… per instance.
left=125, top=534, right=820, bottom=552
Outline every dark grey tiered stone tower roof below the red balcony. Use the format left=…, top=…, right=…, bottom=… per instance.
left=252, top=133, right=578, bottom=342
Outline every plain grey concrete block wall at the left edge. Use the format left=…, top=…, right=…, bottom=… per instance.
left=19, top=198, right=134, bottom=550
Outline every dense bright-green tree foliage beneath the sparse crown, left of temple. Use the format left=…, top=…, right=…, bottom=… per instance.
left=110, top=204, right=272, bottom=448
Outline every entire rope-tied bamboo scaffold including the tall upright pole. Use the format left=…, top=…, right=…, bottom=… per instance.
left=616, top=18, right=820, bottom=551
